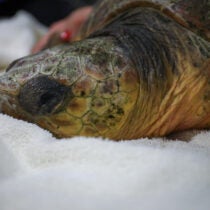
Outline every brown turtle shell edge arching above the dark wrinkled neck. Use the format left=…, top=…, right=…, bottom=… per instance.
left=78, top=0, right=210, bottom=41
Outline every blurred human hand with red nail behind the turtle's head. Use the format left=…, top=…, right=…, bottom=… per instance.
left=31, top=6, right=92, bottom=53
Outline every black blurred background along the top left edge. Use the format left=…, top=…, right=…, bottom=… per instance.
left=0, top=0, right=96, bottom=26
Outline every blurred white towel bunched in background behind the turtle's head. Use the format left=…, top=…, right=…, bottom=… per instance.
left=0, top=11, right=46, bottom=69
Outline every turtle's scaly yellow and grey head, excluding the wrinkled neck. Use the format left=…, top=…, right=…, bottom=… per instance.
left=0, top=39, right=137, bottom=137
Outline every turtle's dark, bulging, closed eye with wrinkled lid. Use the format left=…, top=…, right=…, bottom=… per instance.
left=18, top=76, right=70, bottom=115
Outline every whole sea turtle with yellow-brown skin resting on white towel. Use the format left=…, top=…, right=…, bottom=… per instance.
left=0, top=0, right=210, bottom=140
